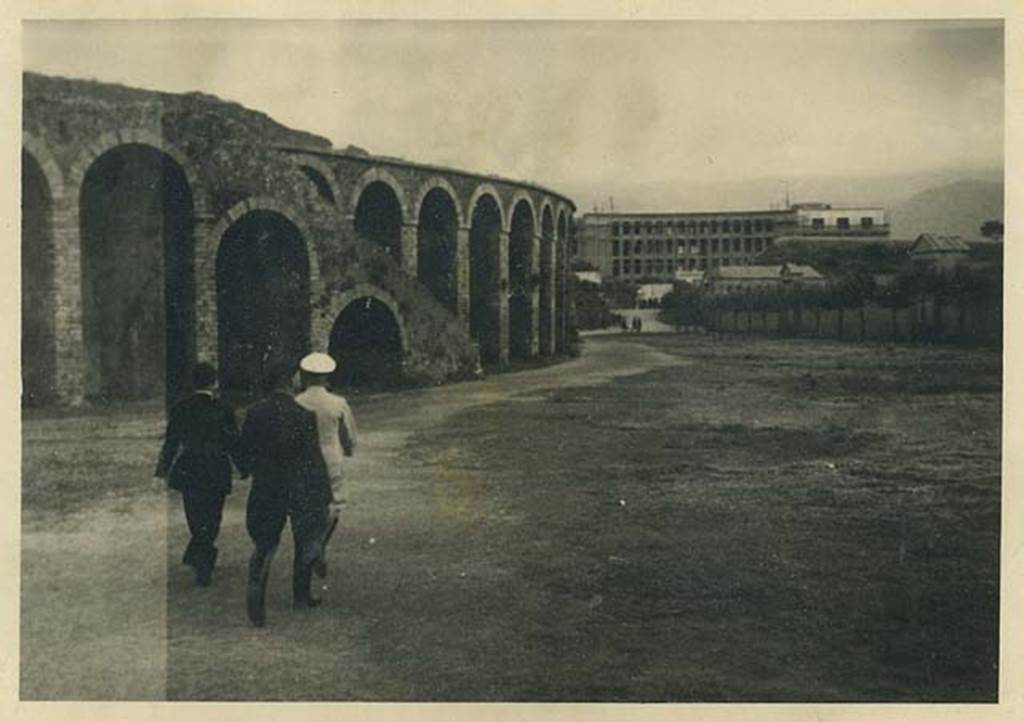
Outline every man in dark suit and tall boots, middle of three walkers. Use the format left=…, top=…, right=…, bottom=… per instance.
left=241, top=367, right=332, bottom=627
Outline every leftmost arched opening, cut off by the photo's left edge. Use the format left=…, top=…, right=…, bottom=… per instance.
left=22, top=150, right=56, bottom=407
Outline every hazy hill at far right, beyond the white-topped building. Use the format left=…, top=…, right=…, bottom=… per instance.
left=889, top=180, right=1002, bottom=239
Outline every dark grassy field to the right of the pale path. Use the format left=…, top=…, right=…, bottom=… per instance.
left=376, top=337, right=1000, bottom=702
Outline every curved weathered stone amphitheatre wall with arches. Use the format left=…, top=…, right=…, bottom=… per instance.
left=22, top=74, right=575, bottom=404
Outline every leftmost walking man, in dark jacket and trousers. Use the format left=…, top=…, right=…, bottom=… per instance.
left=157, top=363, right=239, bottom=587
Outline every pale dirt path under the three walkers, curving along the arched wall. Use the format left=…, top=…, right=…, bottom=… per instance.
left=20, top=339, right=680, bottom=699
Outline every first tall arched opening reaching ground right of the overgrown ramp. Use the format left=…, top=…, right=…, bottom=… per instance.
left=469, top=195, right=502, bottom=364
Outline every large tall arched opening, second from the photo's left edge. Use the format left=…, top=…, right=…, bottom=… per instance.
left=79, top=143, right=196, bottom=402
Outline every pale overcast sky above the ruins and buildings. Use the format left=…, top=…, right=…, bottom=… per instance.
left=24, top=20, right=1004, bottom=208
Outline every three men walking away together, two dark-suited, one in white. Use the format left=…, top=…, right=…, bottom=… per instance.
left=151, top=353, right=356, bottom=627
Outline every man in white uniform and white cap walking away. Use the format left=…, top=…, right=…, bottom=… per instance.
left=295, top=353, right=356, bottom=577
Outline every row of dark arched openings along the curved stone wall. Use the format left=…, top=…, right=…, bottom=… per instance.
left=22, top=136, right=573, bottom=405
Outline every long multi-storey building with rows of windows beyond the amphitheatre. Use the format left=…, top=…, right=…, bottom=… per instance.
left=575, top=204, right=889, bottom=281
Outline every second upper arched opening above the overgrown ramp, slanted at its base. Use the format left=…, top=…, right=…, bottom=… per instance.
left=416, top=188, right=459, bottom=313
